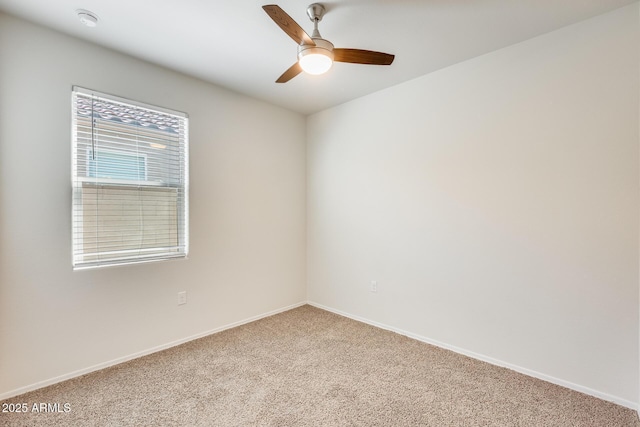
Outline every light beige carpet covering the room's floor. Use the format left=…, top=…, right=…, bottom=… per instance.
left=0, top=306, right=640, bottom=427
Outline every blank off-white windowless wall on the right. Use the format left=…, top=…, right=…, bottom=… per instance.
left=307, top=3, right=639, bottom=407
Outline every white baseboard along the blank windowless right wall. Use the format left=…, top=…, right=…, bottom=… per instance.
left=307, top=301, right=640, bottom=411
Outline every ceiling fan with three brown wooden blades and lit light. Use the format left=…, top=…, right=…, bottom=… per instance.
left=262, top=3, right=395, bottom=83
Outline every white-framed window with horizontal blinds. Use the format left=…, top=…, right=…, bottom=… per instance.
left=72, top=87, right=189, bottom=269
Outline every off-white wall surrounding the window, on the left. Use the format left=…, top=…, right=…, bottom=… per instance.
left=0, top=14, right=306, bottom=399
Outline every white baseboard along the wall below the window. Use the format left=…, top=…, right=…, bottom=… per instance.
left=0, top=301, right=306, bottom=400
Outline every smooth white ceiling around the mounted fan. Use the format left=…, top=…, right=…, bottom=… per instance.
left=0, top=0, right=637, bottom=114
